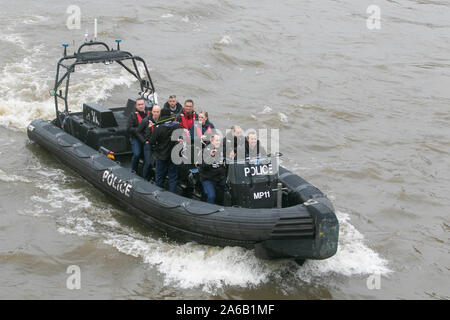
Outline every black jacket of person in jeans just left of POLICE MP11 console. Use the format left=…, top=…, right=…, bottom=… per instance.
left=198, top=145, right=227, bottom=181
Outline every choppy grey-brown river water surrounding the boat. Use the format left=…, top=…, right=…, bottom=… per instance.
left=0, top=0, right=450, bottom=299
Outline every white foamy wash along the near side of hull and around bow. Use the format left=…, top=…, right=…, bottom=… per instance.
left=31, top=158, right=392, bottom=294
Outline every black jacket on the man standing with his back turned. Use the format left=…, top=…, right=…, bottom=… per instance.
left=149, top=117, right=181, bottom=161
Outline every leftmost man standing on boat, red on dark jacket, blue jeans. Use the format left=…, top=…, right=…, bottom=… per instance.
left=127, top=98, right=150, bottom=172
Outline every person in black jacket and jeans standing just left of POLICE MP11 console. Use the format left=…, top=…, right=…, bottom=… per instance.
left=198, top=134, right=227, bottom=204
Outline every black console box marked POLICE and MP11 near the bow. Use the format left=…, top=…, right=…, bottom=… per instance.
left=228, top=157, right=279, bottom=208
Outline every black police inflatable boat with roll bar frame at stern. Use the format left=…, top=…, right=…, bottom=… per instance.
left=27, top=40, right=339, bottom=263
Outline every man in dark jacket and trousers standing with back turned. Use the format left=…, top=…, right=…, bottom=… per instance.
left=149, top=109, right=180, bottom=193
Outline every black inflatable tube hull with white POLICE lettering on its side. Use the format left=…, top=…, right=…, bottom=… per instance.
left=27, top=120, right=339, bottom=260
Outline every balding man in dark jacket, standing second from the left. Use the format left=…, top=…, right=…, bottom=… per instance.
left=136, top=105, right=161, bottom=180
